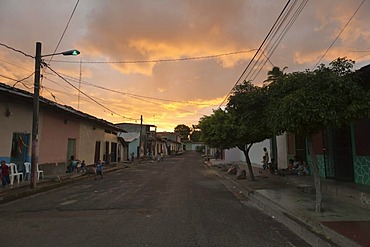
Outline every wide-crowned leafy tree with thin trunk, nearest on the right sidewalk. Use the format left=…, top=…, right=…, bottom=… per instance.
left=268, top=58, right=370, bottom=212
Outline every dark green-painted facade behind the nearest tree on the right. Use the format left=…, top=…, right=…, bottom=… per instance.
left=287, top=119, right=370, bottom=185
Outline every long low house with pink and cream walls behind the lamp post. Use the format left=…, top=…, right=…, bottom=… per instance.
left=0, top=83, right=123, bottom=175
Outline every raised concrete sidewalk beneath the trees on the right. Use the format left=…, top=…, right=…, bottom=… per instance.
left=208, top=160, right=370, bottom=247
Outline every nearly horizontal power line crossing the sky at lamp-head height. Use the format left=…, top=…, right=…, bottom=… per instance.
left=54, top=49, right=256, bottom=64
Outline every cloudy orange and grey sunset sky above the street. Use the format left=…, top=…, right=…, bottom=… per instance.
left=0, top=0, right=370, bottom=131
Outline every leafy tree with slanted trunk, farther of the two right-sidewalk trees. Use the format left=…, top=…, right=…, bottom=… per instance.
left=199, top=81, right=272, bottom=181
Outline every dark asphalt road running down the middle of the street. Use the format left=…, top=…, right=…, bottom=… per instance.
left=0, top=153, right=309, bottom=247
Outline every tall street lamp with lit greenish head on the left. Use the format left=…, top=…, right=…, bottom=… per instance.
left=30, top=42, right=80, bottom=189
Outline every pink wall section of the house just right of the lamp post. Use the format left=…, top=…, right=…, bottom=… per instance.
left=39, top=111, right=80, bottom=164
